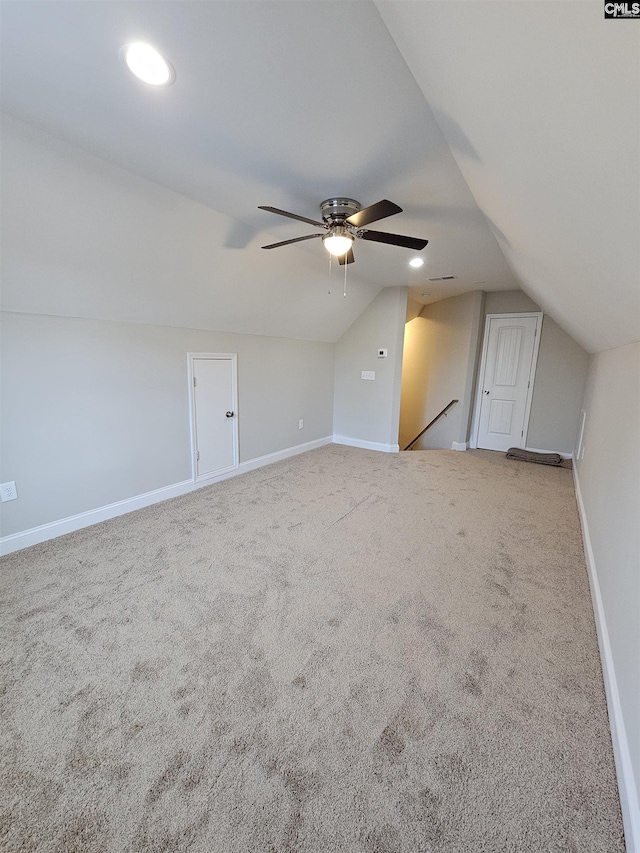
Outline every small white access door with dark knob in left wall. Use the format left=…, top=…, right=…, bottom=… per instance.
left=189, top=354, right=238, bottom=480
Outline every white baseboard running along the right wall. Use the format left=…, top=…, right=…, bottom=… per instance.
left=573, top=464, right=640, bottom=853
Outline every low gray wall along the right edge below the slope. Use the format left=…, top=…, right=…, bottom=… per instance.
left=577, top=343, right=640, bottom=828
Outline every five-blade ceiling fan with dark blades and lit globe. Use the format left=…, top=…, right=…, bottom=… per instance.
left=259, top=198, right=429, bottom=264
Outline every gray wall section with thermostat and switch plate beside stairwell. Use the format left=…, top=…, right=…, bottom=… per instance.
left=333, top=287, right=407, bottom=447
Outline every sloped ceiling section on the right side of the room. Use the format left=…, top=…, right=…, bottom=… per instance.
left=376, top=0, right=640, bottom=351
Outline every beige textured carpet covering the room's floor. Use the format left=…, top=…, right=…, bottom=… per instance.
left=0, top=446, right=624, bottom=853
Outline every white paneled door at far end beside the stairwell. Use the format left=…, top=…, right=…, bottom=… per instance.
left=477, top=315, right=540, bottom=450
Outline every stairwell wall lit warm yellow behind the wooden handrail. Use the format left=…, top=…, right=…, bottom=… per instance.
left=400, top=291, right=483, bottom=449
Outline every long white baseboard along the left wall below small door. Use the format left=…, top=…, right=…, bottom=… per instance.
left=0, top=436, right=333, bottom=556
